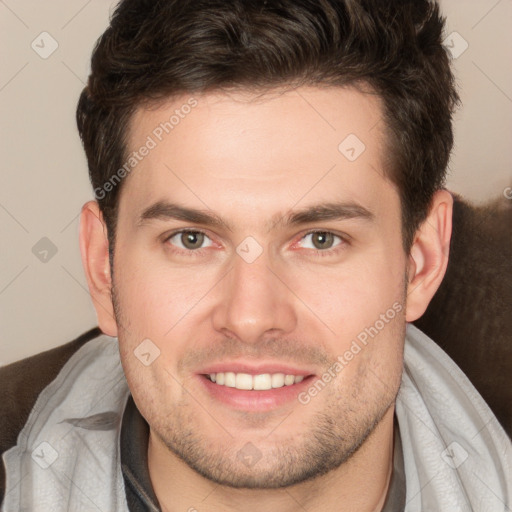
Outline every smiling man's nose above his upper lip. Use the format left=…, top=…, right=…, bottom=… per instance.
left=212, top=248, right=297, bottom=344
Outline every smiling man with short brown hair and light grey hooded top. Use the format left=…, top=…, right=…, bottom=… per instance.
left=4, top=0, right=512, bottom=512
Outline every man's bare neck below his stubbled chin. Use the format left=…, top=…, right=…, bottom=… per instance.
left=148, top=407, right=394, bottom=512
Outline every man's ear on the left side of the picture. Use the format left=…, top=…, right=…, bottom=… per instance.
left=80, top=201, right=117, bottom=336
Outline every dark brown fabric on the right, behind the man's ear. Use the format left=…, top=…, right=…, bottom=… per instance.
left=414, top=197, right=512, bottom=437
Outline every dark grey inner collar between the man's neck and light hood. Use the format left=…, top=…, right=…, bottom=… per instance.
left=121, top=395, right=405, bottom=512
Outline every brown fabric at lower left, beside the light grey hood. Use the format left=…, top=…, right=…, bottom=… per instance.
left=0, top=327, right=101, bottom=502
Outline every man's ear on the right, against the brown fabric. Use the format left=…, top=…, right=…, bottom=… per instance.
left=406, top=190, right=453, bottom=322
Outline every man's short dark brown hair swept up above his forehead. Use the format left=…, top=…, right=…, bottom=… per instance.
left=77, top=0, right=459, bottom=251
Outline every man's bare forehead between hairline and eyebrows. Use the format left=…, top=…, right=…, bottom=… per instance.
left=120, top=87, right=395, bottom=228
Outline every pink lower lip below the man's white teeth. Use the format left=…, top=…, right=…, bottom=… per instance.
left=198, top=375, right=314, bottom=411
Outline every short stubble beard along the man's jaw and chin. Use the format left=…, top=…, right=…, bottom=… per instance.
left=112, top=281, right=407, bottom=489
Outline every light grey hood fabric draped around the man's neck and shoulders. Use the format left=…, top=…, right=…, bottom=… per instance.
left=2, top=324, right=512, bottom=512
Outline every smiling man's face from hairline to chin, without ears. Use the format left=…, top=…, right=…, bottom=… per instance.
left=114, top=88, right=407, bottom=488
